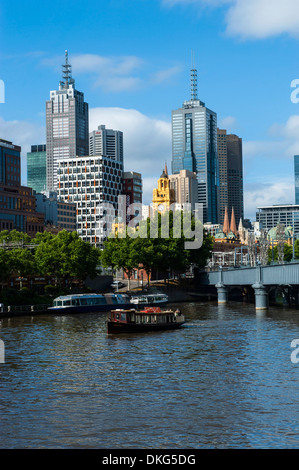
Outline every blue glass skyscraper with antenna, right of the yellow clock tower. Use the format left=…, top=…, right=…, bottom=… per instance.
left=172, top=64, right=219, bottom=223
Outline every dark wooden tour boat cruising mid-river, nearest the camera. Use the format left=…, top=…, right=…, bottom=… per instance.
left=107, top=307, right=185, bottom=333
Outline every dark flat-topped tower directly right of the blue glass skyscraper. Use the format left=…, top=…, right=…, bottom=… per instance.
left=217, top=129, right=244, bottom=224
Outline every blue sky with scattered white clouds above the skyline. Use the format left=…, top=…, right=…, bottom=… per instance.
left=0, top=0, right=299, bottom=220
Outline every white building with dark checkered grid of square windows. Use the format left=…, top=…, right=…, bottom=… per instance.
left=57, top=155, right=123, bottom=247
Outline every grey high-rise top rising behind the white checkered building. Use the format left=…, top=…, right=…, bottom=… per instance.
left=89, top=125, right=124, bottom=162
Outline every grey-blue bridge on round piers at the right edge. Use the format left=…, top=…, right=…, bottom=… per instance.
left=200, top=262, right=299, bottom=310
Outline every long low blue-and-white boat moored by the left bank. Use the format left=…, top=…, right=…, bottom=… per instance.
left=48, top=294, right=132, bottom=314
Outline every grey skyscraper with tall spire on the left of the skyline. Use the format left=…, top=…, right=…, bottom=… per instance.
left=46, top=51, right=89, bottom=191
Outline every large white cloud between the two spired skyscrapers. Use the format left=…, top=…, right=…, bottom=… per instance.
left=89, top=108, right=171, bottom=204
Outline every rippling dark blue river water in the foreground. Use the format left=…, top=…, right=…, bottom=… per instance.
left=0, top=303, right=299, bottom=449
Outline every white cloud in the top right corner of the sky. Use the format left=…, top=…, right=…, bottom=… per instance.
left=162, top=0, right=299, bottom=39
